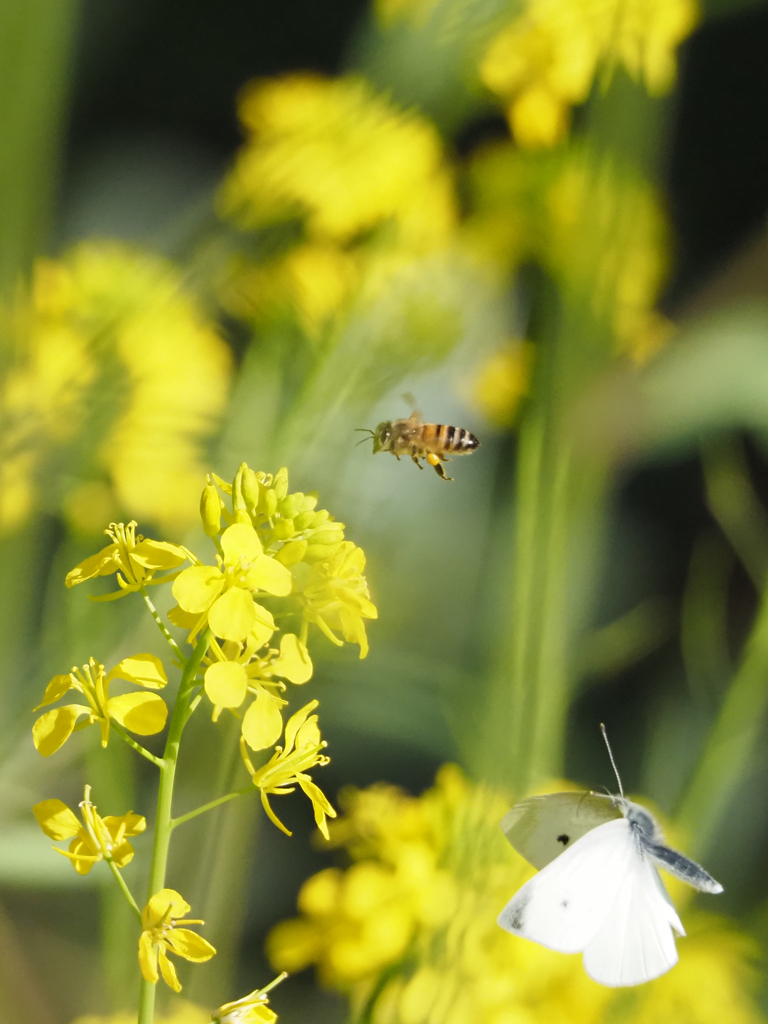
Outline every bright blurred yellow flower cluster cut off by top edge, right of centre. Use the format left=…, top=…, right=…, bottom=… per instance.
left=480, top=0, right=698, bottom=148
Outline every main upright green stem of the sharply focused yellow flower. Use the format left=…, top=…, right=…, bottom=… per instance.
left=137, top=629, right=211, bottom=1024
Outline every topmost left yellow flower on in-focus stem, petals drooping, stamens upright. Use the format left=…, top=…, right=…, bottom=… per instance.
left=65, top=520, right=189, bottom=600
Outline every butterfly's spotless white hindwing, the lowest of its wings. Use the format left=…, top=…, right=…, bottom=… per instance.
left=584, top=850, right=685, bottom=988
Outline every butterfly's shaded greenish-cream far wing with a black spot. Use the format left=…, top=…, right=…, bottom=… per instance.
left=502, top=793, right=622, bottom=869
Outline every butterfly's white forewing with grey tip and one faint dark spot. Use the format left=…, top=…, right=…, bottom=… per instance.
left=499, top=815, right=640, bottom=953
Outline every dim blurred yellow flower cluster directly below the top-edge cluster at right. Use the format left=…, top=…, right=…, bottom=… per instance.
left=464, top=143, right=672, bottom=368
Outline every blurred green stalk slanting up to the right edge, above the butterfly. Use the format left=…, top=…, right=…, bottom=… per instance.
left=677, top=594, right=768, bottom=857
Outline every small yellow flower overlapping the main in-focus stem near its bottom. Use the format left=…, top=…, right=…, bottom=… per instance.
left=138, top=889, right=216, bottom=992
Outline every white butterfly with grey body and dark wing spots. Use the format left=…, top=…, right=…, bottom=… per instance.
left=499, top=739, right=723, bottom=987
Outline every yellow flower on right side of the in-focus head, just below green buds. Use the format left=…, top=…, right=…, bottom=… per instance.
left=294, top=541, right=378, bottom=657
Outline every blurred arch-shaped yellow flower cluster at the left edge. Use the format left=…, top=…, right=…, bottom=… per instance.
left=0, top=242, right=231, bottom=531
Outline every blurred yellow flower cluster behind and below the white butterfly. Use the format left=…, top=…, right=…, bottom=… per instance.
left=267, top=766, right=762, bottom=1024
